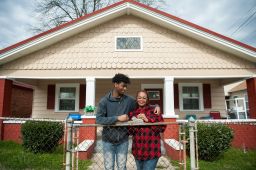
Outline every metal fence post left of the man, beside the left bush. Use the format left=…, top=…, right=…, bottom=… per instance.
left=66, top=118, right=73, bottom=170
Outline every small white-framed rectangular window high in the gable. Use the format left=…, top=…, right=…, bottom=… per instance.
left=116, top=36, right=142, bottom=51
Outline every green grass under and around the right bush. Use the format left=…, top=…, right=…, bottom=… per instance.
left=172, top=148, right=256, bottom=170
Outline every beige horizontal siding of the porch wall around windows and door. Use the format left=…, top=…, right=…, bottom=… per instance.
left=26, top=79, right=226, bottom=119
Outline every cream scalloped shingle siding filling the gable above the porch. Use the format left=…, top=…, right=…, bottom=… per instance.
left=0, top=15, right=255, bottom=77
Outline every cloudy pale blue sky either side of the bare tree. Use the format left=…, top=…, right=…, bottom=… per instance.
left=0, top=0, right=256, bottom=49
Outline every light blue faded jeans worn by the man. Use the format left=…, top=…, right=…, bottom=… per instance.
left=102, top=140, right=129, bottom=170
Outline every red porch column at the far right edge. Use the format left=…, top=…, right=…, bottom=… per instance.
left=246, top=78, right=256, bottom=119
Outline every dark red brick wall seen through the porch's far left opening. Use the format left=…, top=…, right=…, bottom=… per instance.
left=11, top=85, right=33, bottom=117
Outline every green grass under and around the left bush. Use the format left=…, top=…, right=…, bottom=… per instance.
left=0, top=141, right=91, bottom=170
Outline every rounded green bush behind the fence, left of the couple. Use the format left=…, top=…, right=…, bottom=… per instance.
left=21, top=121, right=63, bottom=153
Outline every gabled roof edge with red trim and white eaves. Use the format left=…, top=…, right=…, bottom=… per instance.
left=0, top=0, right=256, bottom=64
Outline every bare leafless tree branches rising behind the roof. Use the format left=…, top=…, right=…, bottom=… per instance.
left=32, top=0, right=164, bottom=33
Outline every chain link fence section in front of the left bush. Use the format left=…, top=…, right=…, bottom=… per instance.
left=0, top=117, right=65, bottom=170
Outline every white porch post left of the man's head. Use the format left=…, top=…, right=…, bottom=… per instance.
left=85, top=77, right=95, bottom=106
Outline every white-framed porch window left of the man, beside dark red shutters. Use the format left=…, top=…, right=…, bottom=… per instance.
left=55, top=84, right=79, bottom=112
